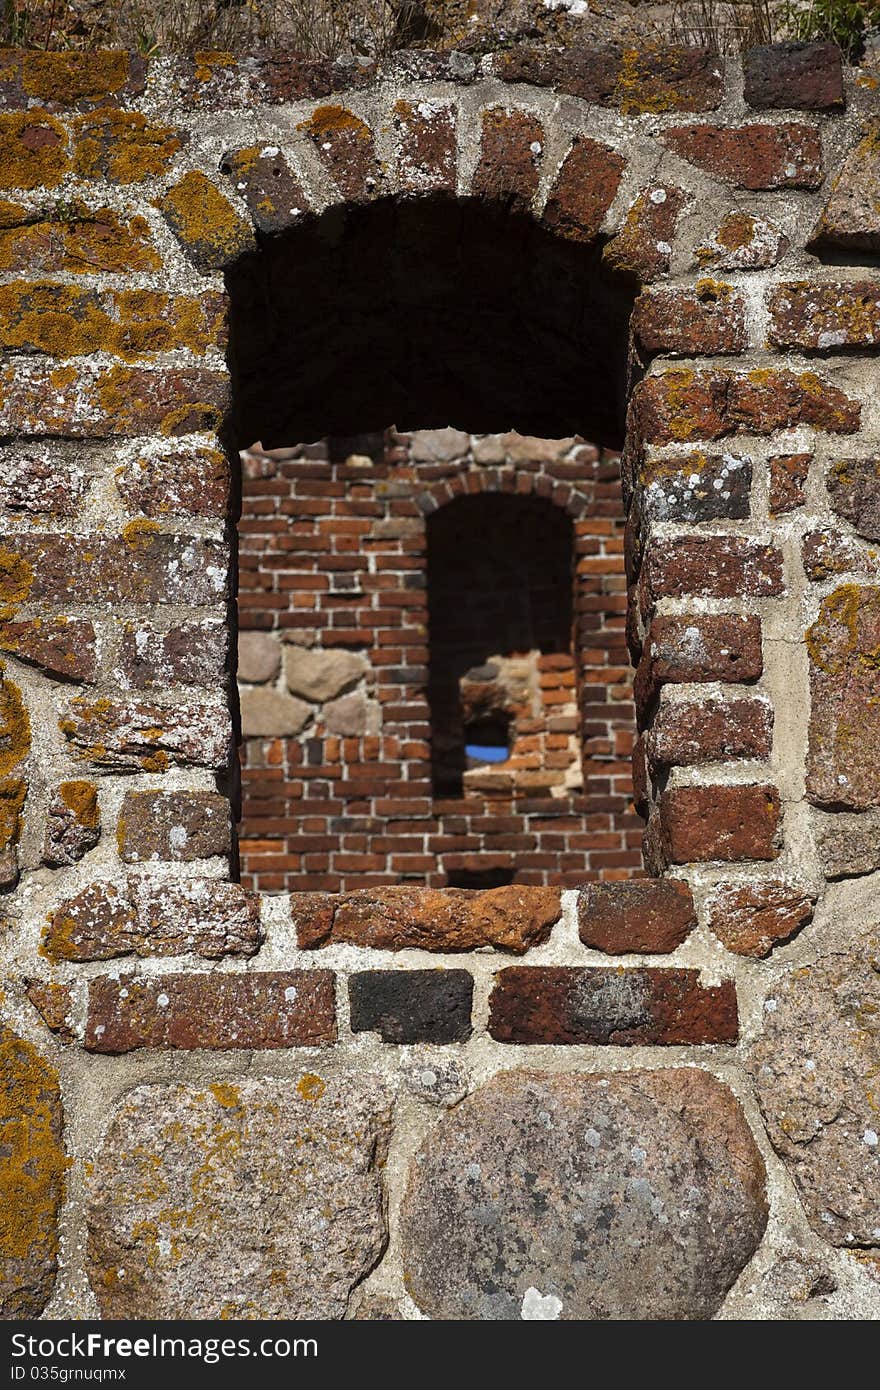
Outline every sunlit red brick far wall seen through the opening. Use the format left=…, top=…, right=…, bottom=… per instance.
left=238, top=430, right=641, bottom=892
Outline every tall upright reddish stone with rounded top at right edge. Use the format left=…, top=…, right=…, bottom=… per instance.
left=806, top=584, right=880, bottom=810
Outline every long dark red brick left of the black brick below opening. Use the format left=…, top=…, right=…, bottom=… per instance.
left=83, top=970, right=336, bottom=1054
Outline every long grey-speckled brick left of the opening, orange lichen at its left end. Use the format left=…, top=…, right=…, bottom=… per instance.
left=4, top=523, right=229, bottom=606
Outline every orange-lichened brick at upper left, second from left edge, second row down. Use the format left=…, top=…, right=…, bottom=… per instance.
left=74, top=111, right=184, bottom=183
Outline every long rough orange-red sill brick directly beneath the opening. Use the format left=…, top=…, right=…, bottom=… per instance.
left=291, top=884, right=562, bottom=955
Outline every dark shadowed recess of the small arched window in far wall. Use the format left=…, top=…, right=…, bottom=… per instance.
left=428, top=492, right=574, bottom=796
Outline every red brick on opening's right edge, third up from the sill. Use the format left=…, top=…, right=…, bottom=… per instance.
left=635, top=613, right=763, bottom=710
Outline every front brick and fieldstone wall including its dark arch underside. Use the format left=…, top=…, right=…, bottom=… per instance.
left=0, top=46, right=880, bottom=1319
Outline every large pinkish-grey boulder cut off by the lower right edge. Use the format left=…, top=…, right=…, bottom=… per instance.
left=752, top=927, right=880, bottom=1245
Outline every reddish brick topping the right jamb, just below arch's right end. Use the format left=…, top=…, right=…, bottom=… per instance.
left=631, top=279, right=748, bottom=357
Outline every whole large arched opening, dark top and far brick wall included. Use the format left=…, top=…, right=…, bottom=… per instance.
left=222, top=199, right=641, bottom=892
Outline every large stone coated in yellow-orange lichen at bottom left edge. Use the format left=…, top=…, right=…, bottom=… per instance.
left=0, top=1038, right=71, bottom=1265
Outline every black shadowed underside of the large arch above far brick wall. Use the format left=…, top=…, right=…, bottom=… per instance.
left=227, top=197, right=633, bottom=448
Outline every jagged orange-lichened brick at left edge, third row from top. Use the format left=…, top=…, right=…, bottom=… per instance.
left=0, top=202, right=161, bottom=275
